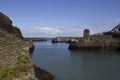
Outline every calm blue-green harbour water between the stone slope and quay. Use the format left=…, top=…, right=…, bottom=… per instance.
left=32, top=41, right=120, bottom=80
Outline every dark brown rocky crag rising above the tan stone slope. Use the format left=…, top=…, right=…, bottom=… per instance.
left=0, top=12, right=23, bottom=39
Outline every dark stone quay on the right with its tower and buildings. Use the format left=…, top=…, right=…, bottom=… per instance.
left=69, top=24, right=120, bottom=50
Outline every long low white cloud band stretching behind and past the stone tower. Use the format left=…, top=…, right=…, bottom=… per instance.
left=23, top=24, right=113, bottom=37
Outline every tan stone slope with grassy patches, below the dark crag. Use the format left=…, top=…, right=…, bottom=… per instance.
left=0, top=29, right=37, bottom=80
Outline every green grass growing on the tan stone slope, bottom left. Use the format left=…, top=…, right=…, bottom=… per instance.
left=0, top=54, right=29, bottom=80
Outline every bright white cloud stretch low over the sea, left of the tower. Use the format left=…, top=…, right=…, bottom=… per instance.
left=23, top=27, right=82, bottom=36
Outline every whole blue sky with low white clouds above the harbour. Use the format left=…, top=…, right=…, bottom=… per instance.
left=0, top=0, right=120, bottom=37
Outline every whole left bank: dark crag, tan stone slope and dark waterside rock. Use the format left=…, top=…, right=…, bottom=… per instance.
left=0, top=13, right=53, bottom=80
